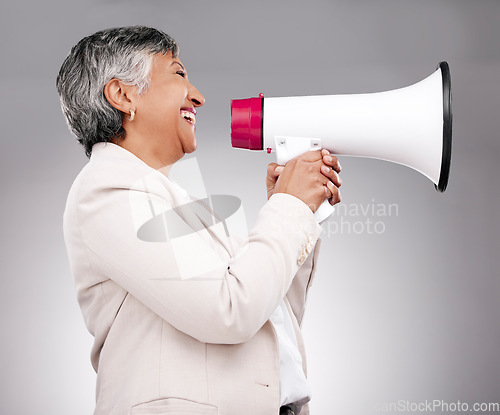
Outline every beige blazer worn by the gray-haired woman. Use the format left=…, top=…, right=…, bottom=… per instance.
left=64, top=143, right=321, bottom=415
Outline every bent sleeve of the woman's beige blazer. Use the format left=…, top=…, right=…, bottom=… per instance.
left=64, top=171, right=321, bottom=344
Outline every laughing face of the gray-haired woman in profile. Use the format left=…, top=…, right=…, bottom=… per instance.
left=132, top=52, right=205, bottom=161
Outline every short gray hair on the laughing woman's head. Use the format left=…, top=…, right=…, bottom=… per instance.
left=56, top=26, right=179, bottom=157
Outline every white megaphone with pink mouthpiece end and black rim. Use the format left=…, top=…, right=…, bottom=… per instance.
left=231, top=62, right=452, bottom=221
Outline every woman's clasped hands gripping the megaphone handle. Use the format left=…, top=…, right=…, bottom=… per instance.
left=266, top=150, right=342, bottom=212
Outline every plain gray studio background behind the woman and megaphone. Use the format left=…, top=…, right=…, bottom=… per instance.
left=0, top=0, right=500, bottom=415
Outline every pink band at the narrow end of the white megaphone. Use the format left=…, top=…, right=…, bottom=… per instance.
left=231, top=94, right=264, bottom=150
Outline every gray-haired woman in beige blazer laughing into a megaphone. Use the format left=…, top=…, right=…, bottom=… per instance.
left=57, top=27, right=340, bottom=415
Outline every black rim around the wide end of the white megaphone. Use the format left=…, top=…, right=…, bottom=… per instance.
left=434, top=61, right=453, bottom=192
